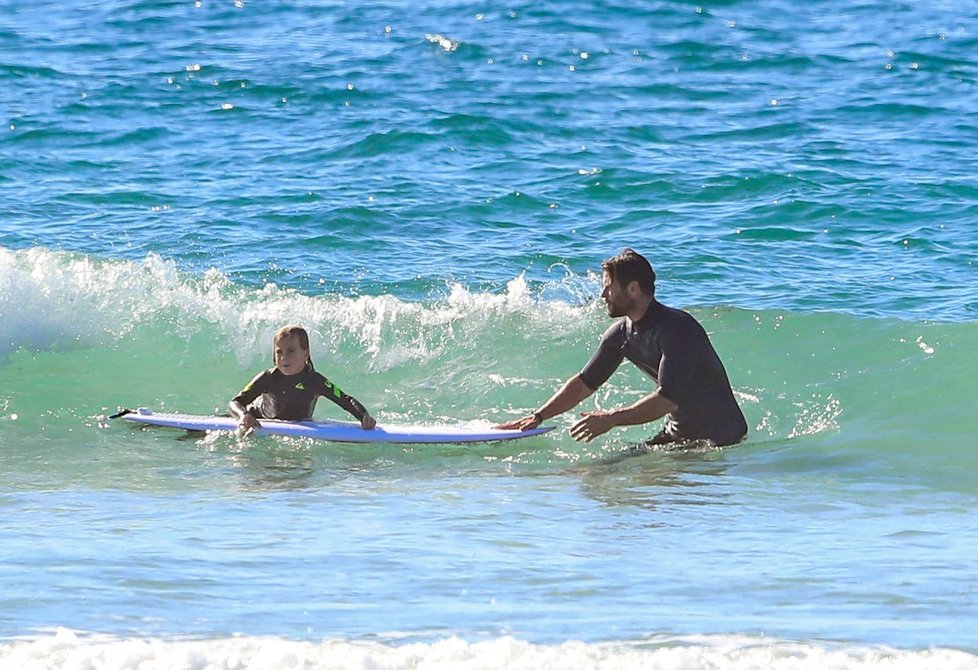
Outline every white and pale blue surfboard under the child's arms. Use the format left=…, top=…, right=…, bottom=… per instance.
left=112, top=407, right=553, bottom=444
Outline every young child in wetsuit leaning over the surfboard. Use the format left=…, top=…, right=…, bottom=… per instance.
left=228, top=326, right=377, bottom=431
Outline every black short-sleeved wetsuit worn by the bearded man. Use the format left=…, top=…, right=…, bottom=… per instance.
left=581, top=300, right=747, bottom=445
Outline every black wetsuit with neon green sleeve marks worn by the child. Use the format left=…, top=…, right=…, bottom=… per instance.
left=232, top=366, right=367, bottom=421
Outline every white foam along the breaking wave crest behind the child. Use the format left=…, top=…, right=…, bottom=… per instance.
left=0, top=247, right=590, bottom=370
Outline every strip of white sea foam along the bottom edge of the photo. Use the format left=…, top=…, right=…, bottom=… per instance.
left=0, top=629, right=978, bottom=670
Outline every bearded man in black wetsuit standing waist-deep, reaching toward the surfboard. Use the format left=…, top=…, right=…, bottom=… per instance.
left=499, top=249, right=747, bottom=446
